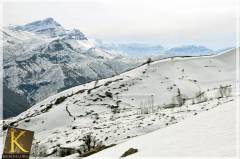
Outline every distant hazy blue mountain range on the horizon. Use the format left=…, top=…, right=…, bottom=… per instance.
left=93, top=40, right=216, bottom=57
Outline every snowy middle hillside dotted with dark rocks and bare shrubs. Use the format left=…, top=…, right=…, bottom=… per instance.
left=3, top=50, right=236, bottom=158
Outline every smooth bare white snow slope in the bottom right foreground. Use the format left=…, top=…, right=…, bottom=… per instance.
left=88, top=98, right=237, bottom=159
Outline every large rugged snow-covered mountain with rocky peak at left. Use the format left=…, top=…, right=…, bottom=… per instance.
left=1, top=18, right=140, bottom=117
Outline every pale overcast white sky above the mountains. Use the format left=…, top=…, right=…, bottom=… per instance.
left=3, top=0, right=236, bottom=49
